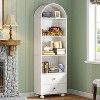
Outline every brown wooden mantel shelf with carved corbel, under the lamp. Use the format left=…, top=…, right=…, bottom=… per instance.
left=0, top=40, right=20, bottom=56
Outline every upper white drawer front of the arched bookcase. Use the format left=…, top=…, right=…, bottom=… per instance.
left=41, top=73, right=67, bottom=84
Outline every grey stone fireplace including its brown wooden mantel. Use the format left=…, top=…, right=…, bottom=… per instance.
left=0, top=40, right=20, bottom=97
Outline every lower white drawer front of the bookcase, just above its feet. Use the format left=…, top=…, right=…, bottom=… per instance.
left=41, top=84, right=67, bottom=95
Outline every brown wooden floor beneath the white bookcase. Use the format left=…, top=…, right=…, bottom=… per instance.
left=28, top=94, right=92, bottom=100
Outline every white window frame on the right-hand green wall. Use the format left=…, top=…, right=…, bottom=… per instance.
left=86, top=0, right=100, bottom=61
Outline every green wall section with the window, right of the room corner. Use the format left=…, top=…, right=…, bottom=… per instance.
left=71, top=0, right=100, bottom=93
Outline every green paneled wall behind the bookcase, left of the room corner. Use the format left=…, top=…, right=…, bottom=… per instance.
left=4, top=0, right=71, bottom=92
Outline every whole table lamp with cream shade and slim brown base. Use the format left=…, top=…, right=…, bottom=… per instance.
left=4, top=15, right=18, bottom=40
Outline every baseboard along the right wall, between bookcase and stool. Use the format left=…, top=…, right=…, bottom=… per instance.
left=68, top=89, right=100, bottom=100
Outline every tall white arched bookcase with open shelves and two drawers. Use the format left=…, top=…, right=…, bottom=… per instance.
left=34, top=3, right=67, bottom=98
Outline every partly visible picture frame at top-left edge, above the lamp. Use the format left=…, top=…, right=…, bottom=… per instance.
left=0, top=0, right=4, bottom=29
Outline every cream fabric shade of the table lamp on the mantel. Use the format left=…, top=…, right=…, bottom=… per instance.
left=4, top=15, right=18, bottom=27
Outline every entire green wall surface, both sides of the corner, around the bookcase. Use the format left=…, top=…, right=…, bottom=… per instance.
left=4, top=0, right=100, bottom=92
